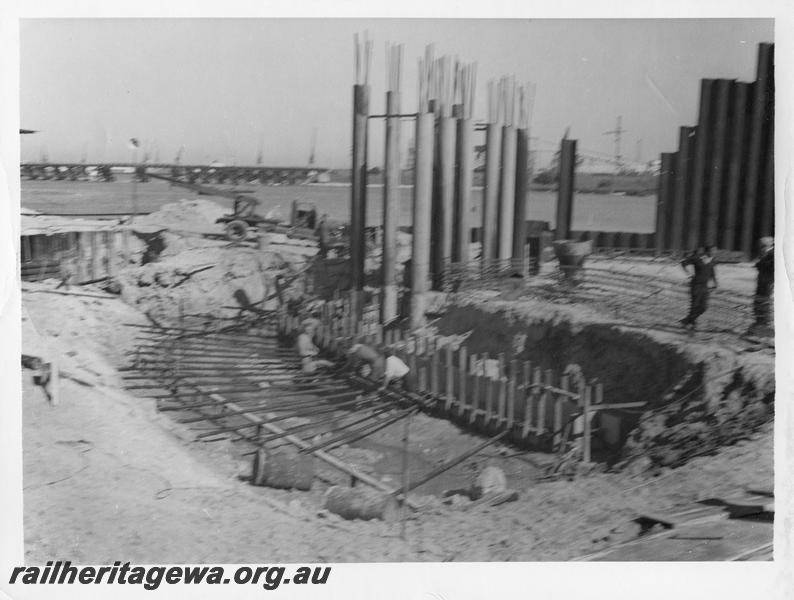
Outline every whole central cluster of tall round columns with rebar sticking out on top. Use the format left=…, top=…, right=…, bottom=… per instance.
left=351, top=37, right=534, bottom=328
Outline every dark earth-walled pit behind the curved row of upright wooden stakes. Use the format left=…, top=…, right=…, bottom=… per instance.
left=434, top=306, right=774, bottom=466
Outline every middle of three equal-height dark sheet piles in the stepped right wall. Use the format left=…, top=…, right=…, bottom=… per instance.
left=703, top=79, right=733, bottom=246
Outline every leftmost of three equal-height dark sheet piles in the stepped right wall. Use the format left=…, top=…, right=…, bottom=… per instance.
left=686, top=79, right=715, bottom=250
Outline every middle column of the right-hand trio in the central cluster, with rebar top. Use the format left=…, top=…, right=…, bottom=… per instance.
left=497, top=77, right=516, bottom=263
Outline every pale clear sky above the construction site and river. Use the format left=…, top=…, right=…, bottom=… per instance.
left=20, top=19, right=774, bottom=168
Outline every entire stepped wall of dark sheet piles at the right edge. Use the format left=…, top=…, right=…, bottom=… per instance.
left=656, top=44, right=775, bottom=256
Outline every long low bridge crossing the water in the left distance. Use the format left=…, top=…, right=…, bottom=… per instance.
left=19, top=162, right=328, bottom=185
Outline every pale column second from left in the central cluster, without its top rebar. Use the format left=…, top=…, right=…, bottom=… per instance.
left=381, top=91, right=401, bottom=323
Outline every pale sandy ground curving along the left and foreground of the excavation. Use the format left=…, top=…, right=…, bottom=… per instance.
left=23, top=283, right=773, bottom=563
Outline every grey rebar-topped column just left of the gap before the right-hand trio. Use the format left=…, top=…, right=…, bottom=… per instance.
left=452, top=63, right=477, bottom=264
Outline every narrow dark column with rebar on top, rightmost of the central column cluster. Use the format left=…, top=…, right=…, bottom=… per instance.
left=513, top=84, right=535, bottom=264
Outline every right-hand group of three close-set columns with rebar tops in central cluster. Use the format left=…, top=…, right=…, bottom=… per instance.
left=480, top=77, right=534, bottom=269
